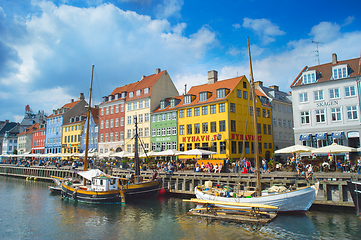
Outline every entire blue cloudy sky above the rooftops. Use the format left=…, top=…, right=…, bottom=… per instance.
left=0, top=0, right=361, bottom=122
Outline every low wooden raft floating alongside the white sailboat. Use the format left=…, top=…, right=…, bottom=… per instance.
left=183, top=199, right=277, bottom=224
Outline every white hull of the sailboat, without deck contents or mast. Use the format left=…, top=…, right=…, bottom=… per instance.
left=194, top=183, right=319, bottom=212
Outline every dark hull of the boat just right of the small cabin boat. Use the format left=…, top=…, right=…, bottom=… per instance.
left=122, top=180, right=161, bottom=199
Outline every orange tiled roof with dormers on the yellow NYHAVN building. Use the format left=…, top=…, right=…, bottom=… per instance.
left=178, top=75, right=248, bottom=107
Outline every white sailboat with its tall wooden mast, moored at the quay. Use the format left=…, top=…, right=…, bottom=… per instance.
left=194, top=40, right=319, bottom=212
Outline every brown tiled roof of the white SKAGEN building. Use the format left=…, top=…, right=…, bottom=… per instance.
left=291, top=58, right=361, bottom=87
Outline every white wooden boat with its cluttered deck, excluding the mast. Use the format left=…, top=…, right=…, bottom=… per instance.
left=194, top=182, right=319, bottom=212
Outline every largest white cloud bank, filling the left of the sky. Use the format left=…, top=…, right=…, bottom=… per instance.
left=0, top=2, right=216, bottom=119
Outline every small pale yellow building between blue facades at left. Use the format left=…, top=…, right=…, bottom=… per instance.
left=62, top=114, right=86, bottom=153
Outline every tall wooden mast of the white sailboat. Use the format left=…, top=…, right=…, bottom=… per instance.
left=247, top=37, right=261, bottom=196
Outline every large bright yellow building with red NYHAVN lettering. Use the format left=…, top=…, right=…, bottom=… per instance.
left=178, top=71, right=273, bottom=159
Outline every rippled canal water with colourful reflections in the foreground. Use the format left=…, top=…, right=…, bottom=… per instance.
left=0, top=177, right=361, bottom=240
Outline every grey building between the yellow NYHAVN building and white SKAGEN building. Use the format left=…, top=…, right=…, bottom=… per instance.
left=255, top=81, right=295, bottom=150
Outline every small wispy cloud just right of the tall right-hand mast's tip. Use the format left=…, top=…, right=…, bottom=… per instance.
left=242, top=17, right=286, bottom=44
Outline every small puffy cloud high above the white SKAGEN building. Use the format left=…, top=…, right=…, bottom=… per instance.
left=309, top=22, right=341, bottom=42
